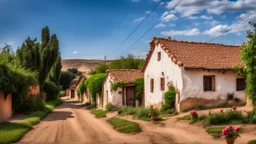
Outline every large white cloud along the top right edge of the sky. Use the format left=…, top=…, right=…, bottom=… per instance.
left=167, top=0, right=256, bottom=17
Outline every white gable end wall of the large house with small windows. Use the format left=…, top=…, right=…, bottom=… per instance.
left=144, top=45, right=183, bottom=107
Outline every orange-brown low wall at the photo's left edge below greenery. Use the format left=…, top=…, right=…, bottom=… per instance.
left=0, top=91, right=12, bottom=122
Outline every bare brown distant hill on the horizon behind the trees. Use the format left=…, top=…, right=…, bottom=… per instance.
left=61, top=59, right=110, bottom=73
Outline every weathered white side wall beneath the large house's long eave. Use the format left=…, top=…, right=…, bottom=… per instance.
left=180, top=69, right=245, bottom=101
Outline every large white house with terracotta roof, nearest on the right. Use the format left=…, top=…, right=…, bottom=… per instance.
left=142, top=38, right=246, bottom=112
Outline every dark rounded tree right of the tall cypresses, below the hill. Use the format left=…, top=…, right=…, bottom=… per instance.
left=60, top=71, right=75, bottom=90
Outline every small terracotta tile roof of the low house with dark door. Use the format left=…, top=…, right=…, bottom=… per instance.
left=107, top=69, right=144, bottom=83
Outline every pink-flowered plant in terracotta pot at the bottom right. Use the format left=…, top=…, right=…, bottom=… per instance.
left=222, top=125, right=240, bottom=144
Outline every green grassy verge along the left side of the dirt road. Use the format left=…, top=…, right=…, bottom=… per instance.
left=0, top=100, right=61, bottom=144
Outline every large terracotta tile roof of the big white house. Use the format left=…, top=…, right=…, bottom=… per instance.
left=142, top=38, right=241, bottom=71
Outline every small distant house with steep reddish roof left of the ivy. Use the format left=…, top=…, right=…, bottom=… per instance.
left=75, top=74, right=91, bottom=103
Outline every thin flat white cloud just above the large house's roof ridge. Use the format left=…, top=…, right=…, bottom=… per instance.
left=161, top=28, right=200, bottom=36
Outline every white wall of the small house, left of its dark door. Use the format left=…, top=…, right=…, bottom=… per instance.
left=103, top=76, right=123, bottom=109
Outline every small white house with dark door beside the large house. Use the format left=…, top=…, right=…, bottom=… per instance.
left=103, top=69, right=144, bottom=108
